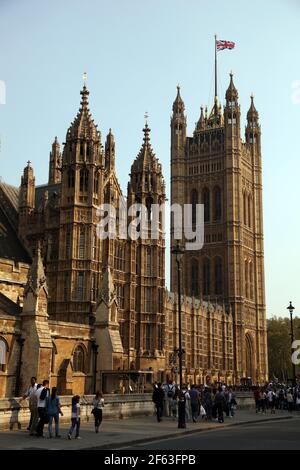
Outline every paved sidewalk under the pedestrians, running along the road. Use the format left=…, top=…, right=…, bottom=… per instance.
left=0, top=410, right=299, bottom=450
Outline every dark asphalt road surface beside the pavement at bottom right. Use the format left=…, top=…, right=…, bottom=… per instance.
left=127, top=419, right=300, bottom=450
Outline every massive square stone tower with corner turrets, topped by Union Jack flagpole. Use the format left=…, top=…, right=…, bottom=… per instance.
left=171, top=74, right=267, bottom=382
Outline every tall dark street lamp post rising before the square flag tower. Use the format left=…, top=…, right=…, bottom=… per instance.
left=172, top=242, right=186, bottom=428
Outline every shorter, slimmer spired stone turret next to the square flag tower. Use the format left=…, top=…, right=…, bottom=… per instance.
left=128, top=123, right=166, bottom=371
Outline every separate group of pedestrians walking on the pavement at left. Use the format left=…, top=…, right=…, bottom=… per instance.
left=23, top=377, right=104, bottom=439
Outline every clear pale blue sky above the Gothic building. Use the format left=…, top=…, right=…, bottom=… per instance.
left=0, top=0, right=300, bottom=316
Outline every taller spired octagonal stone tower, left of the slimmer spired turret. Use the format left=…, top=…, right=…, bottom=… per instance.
left=47, top=85, right=104, bottom=323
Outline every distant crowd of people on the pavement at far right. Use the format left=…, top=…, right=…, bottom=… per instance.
left=253, top=384, right=300, bottom=414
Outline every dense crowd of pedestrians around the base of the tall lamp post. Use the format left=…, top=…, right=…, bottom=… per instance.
left=152, top=381, right=237, bottom=423
